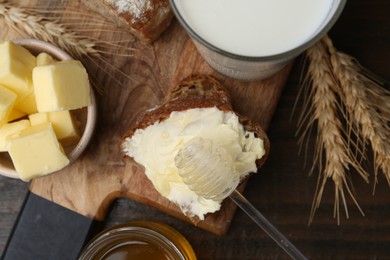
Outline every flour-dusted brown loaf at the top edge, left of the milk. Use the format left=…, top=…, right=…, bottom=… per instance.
left=81, top=0, right=173, bottom=43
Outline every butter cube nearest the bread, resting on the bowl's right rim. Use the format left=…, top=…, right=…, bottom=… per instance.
left=33, top=60, right=91, bottom=112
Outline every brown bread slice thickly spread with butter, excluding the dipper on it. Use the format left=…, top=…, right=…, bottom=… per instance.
left=121, top=75, right=270, bottom=224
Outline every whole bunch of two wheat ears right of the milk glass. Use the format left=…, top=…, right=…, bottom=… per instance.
left=297, top=36, right=390, bottom=224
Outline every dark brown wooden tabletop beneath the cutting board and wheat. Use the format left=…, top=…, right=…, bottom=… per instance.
left=0, top=0, right=390, bottom=259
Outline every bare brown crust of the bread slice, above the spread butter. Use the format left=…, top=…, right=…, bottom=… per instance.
left=122, top=75, right=270, bottom=171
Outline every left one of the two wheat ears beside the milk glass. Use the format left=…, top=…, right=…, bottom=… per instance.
left=298, top=39, right=368, bottom=224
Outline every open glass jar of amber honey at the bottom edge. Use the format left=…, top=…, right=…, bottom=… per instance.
left=79, top=221, right=196, bottom=260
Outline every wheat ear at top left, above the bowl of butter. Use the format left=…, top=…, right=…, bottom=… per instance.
left=0, top=0, right=134, bottom=92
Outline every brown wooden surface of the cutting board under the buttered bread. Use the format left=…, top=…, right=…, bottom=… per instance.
left=0, top=1, right=291, bottom=235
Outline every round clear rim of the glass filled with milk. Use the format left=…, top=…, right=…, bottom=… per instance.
left=169, top=0, right=347, bottom=62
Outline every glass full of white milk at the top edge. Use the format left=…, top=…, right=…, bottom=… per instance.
left=170, top=0, right=346, bottom=80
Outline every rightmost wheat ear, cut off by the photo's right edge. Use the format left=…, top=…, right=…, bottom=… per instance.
left=322, top=37, right=390, bottom=191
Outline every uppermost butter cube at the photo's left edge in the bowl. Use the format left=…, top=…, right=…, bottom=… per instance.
left=0, top=41, right=36, bottom=102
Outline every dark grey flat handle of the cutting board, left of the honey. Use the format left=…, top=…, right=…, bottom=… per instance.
left=1, top=191, right=102, bottom=260
